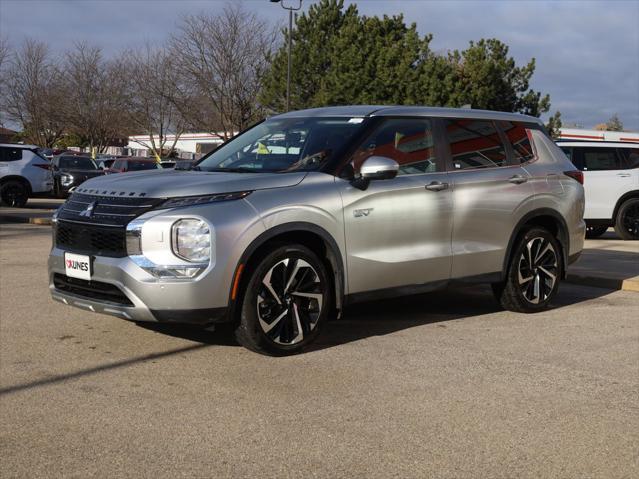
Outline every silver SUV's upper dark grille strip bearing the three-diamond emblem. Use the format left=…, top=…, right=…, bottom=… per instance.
left=58, top=191, right=164, bottom=226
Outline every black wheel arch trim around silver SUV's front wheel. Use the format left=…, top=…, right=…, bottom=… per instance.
left=228, top=221, right=345, bottom=317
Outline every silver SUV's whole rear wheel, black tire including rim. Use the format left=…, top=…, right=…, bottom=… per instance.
left=492, top=227, right=564, bottom=313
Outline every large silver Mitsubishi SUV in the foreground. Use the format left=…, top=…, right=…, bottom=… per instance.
left=49, top=106, right=585, bottom=354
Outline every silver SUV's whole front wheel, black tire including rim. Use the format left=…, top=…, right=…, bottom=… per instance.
left=235, top=245, right=333, bottom=356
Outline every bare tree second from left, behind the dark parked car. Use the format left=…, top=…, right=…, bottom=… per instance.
left=63, top=43, right=128, bottom=152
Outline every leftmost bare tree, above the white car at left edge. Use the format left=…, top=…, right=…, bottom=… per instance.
left=2, top=40, right=66, bottom=147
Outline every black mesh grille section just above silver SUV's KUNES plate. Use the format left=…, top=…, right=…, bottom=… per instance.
left=55, top=220, right=126, bottom=258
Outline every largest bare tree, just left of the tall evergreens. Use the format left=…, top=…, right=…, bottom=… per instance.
left=170, top=3, right=276, bottom=139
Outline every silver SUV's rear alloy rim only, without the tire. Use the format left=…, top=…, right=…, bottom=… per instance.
left=517, top=237, right=559, bottom=304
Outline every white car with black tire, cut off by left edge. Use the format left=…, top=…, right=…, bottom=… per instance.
left=0, top=143, right=53, bottom=207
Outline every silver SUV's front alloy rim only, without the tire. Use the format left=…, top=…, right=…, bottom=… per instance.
left=257, top=258, right=325, bottom=345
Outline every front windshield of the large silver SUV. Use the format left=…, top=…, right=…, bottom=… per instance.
left=194, top=118, right=363, bottom=173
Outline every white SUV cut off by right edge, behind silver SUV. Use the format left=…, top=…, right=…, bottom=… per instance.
left=557, top=141, right=639, bottom=240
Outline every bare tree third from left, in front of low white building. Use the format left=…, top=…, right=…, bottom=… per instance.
left=123, top=44, right=184, bottom=161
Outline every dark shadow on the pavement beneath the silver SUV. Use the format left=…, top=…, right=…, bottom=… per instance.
left=138, top=284, right=611, bottom=352
